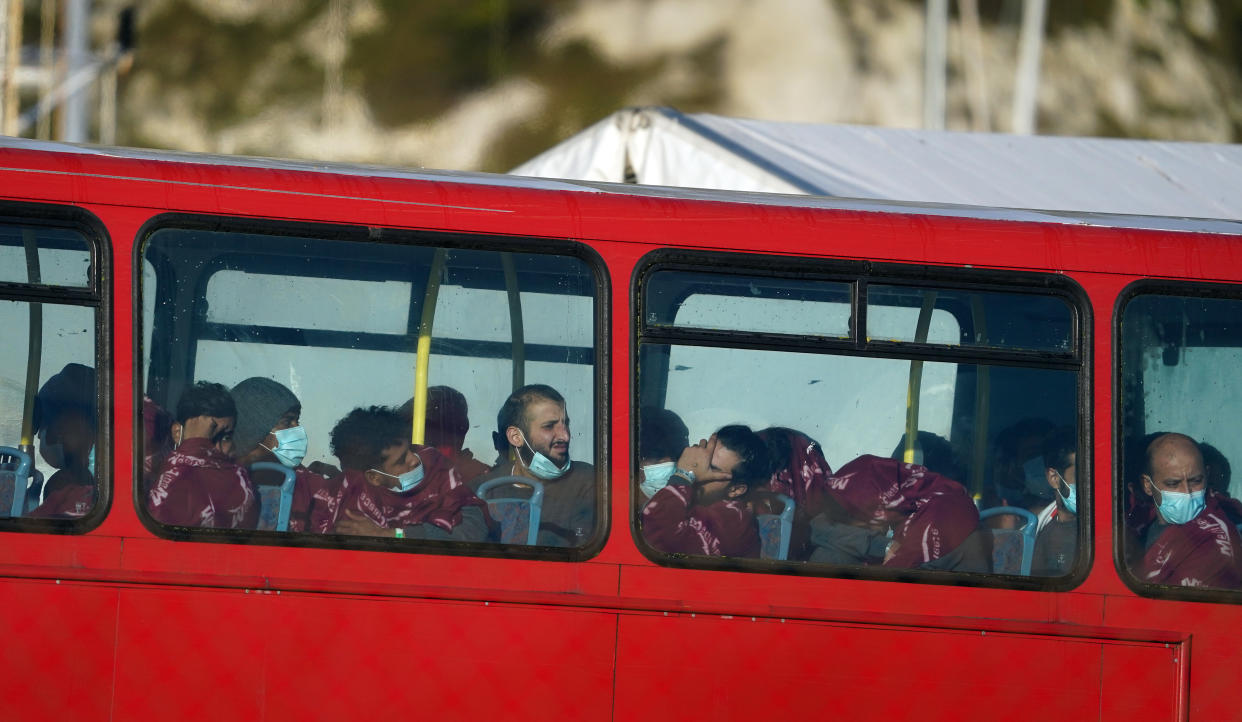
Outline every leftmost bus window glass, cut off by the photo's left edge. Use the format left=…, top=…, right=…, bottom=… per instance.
left=0, top=220, right=108, bottom=531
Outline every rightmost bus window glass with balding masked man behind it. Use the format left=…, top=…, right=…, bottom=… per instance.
left=1117, top=285, right=1242, bottom=599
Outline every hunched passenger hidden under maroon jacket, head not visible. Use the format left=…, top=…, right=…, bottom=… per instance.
left=811, top=455, right=991, bottom=573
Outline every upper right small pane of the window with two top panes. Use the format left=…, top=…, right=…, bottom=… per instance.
left=867, top=283, right=1073, bottom=352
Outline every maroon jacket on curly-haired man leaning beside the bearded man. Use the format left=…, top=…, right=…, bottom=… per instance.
left=308, top=446, right=489, bottom=533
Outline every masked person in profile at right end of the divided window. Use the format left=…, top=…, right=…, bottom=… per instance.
left=1031, top=426, right=1078, bottom=577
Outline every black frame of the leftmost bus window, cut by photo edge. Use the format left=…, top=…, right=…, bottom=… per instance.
left=0, top=201, right=116, bottom=534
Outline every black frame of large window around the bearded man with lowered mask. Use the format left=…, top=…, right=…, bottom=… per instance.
left=132, top=212, right=612, bottom=562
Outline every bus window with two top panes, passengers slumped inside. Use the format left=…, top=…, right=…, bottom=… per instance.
left=633, top=255, right=1087, bottom=584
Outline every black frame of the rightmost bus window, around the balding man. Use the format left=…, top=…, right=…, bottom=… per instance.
left=1109, top=278, right=1242, bottom=605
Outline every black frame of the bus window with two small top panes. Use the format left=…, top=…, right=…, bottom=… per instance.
left=628, top=249, right=1095, bottom=592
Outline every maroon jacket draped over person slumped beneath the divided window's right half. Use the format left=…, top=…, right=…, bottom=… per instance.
left=828, top=455, right=979, bottom=569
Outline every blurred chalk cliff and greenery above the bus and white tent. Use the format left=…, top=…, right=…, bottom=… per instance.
left=0, top=0, right=1242, bottom=171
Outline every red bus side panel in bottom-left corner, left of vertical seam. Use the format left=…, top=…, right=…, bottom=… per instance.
left=0, top=580, right=118, bottom=722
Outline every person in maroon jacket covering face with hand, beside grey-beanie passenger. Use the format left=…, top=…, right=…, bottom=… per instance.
left=147, top=382, right=258, bottom=529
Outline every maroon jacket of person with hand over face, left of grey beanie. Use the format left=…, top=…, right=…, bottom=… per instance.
left=147, top=439, right=258, bottom=529
